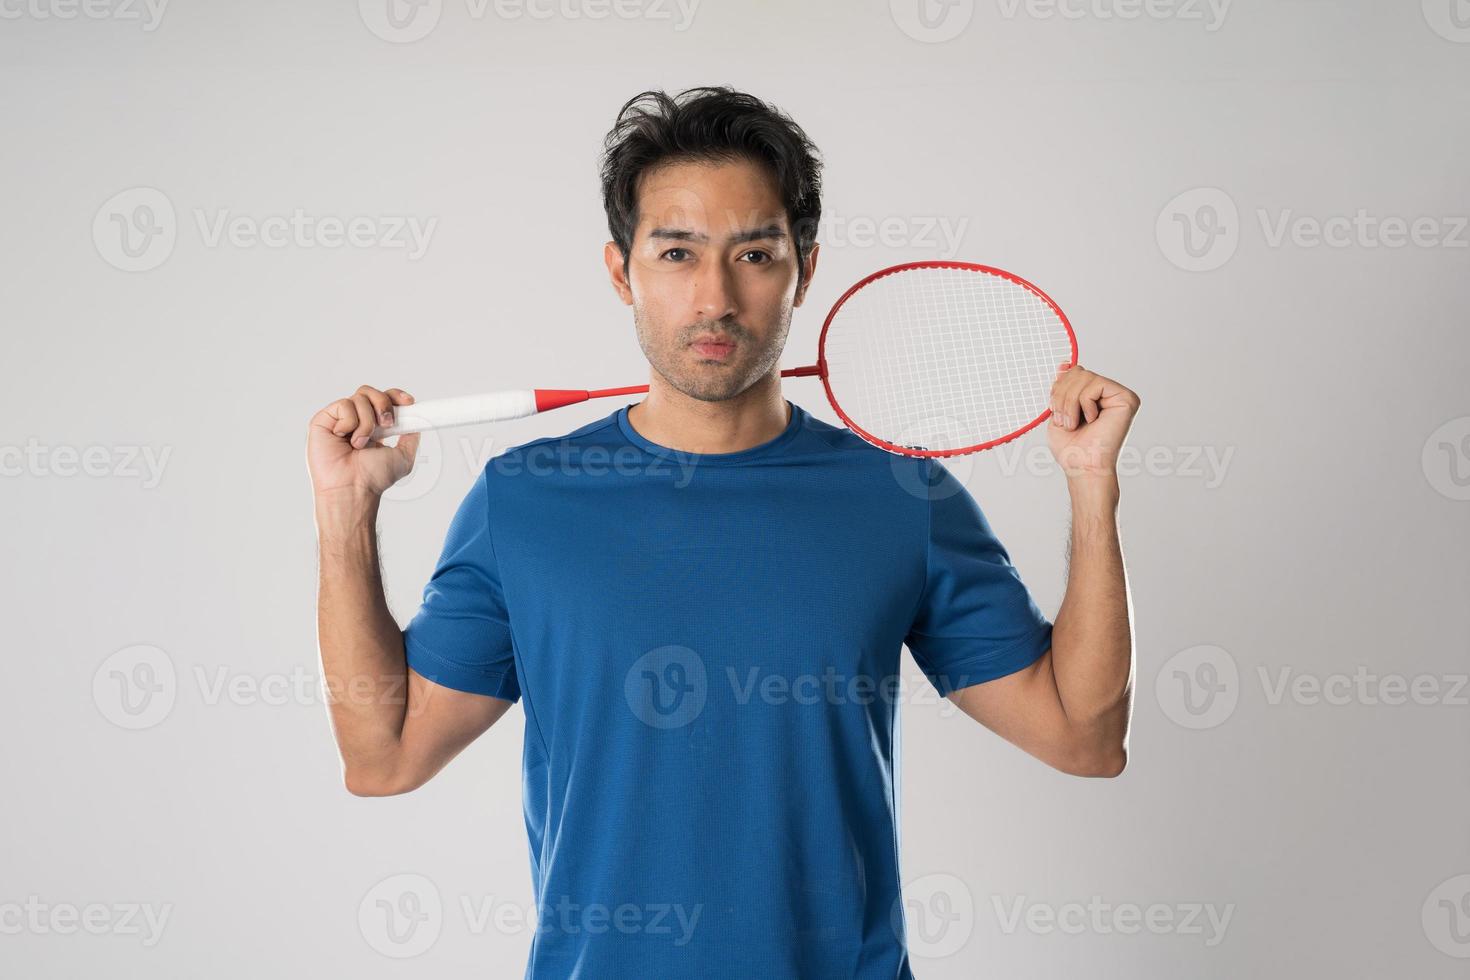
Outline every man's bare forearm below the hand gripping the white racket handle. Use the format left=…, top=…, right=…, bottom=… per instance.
left=316, top=494, right=409, bottom=785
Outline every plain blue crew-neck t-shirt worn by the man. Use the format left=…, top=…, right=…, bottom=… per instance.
left=404, top=403, right=1051, bottom=980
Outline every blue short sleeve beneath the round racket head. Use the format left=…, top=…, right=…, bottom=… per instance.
left=904, top=458, right=1051, bottom=695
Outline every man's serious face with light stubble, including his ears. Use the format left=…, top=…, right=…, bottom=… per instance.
left=606, top=160, right=816, bottom=401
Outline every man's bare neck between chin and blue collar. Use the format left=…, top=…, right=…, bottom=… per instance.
left=628, top=372, right=791, bottom=454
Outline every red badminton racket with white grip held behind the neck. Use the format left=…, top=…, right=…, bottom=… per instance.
left=372, top=262, right=1078, bottom=455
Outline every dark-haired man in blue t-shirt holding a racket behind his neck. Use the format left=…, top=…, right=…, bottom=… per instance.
left=307, top=88, right=1139, bottom=980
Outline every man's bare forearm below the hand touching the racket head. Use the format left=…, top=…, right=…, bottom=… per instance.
left=1053, top=476, right=1133, bottom=757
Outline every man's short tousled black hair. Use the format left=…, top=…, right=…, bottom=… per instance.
left=601, top=85, right=822, bottom=285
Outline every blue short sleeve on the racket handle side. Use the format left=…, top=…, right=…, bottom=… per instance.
left=403, top=472, right=520, bottom=701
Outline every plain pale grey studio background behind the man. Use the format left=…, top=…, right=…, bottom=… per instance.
left=0, top=0, right=1470, bottom=980
